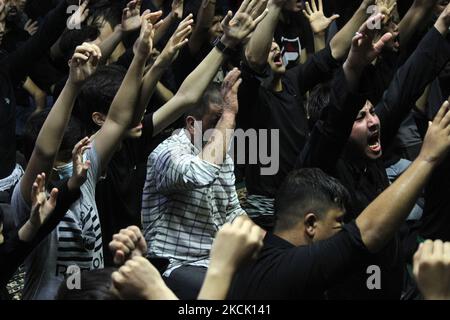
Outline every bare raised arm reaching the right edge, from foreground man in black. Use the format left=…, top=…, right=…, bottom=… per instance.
left=356, top=97, right=450, bottom=252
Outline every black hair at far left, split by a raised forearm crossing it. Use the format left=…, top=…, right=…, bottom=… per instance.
left=24, top=109, right=87, bottom=161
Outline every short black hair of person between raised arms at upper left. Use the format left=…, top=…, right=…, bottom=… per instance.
left=74, top=65, right=126, bottom=132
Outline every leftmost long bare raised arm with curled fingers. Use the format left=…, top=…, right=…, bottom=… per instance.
left=20, top=43, right=101, bottom=205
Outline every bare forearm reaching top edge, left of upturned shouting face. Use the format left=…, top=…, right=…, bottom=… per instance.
left=245, top=1, right=282, bottom=69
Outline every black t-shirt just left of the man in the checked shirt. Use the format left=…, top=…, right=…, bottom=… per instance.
left=95, top=114, right=153, bottom=265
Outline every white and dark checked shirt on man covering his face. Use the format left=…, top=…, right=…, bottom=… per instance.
left=142, top=130, right=245, bottom=276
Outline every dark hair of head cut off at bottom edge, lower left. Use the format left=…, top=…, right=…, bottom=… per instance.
left=56, top=268, right=120, bottom=300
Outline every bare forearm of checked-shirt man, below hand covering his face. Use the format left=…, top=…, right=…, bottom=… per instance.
left=200, top=111, right=236, bottom=166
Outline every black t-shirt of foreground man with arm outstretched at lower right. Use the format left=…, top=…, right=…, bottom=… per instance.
left=229, top=222, right=368, bottom=300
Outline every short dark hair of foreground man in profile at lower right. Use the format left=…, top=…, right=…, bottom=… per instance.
left=275, top=168, right=350, bottom=231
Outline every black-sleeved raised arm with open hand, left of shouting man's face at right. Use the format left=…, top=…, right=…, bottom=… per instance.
left=296, top=14, right=392, bottom=174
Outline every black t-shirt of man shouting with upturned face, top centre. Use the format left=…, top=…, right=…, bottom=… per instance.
left=237, top=48, right=338, bottom=198
